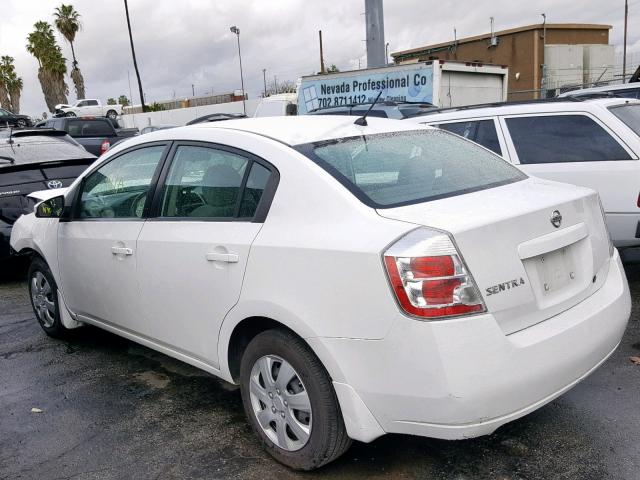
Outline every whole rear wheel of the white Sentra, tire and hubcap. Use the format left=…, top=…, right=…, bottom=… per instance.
left=240, top=330, right=351, bottom=470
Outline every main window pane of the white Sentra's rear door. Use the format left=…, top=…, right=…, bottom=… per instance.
left=161, top=146, right=248, bottom=218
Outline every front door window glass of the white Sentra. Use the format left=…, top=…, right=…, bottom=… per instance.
left=78, top=146, right=165, bottom=218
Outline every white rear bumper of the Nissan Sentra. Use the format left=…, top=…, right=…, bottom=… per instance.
left=309, top=252, right=631, bottom=441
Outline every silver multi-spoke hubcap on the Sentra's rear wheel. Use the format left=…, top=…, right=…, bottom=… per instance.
left=249, top=355, right=311, bottom=452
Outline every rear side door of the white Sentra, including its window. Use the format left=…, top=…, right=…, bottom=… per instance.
left=137, top=142, right=277, bottom=368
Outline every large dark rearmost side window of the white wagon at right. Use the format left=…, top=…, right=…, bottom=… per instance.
left=506, top=115, right=630, bottom=164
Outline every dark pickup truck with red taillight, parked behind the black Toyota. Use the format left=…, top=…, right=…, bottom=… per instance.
left=45, top=117, right=138, bottom=156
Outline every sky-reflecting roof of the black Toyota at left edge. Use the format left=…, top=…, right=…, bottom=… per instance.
left=0, top=135, right=96, bottom=170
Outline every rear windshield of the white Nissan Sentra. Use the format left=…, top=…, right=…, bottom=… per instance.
left=296, top=130, right=527, bottom=208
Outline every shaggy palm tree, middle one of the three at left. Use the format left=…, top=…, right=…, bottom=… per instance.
left=27, top=21, right=69, bottom=112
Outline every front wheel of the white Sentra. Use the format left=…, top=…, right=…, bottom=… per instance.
left=27, top=258, right=69, bottom=338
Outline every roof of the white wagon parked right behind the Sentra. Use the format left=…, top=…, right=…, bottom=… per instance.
left=405, top=97, right=640, bottom=123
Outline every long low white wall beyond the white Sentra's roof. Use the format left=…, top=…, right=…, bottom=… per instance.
left=119, top=98, right=261, bottom=130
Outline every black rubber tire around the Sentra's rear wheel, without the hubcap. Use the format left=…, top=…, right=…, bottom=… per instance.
left=240, top=330, right=352, bottom=470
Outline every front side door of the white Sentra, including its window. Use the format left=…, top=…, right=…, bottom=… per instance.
left=58, top=143, right=169, bottom=328
